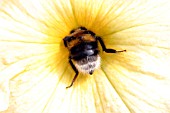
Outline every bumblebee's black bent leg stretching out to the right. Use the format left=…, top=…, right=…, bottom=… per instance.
left=96, top=36, right=126, bottom=53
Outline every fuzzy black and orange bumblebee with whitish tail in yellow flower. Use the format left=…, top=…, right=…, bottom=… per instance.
left=63, top=27, right=126, bottom=88
